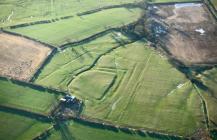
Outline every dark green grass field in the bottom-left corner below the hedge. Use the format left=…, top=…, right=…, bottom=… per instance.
left=0, top=110, right=51, bottom=140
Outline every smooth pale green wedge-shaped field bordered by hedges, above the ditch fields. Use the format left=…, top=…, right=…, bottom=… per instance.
left=5, top=8, right=141, bottom=46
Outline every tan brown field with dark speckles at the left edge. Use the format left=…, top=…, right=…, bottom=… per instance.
left=0, top=32, right=51, bottom=80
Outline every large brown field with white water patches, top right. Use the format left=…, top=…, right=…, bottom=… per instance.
left=151, top=4, right=217, bottom=65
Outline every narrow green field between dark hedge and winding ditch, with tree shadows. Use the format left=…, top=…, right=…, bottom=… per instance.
left=35, top=32, right=131, bottom=90
